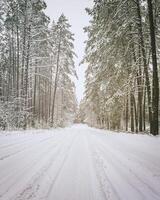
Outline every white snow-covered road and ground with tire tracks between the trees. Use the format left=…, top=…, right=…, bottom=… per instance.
left=0, top=125, right=160, bottom=200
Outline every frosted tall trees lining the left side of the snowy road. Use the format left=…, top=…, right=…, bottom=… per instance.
left=0, top=0, right=76, bottom=129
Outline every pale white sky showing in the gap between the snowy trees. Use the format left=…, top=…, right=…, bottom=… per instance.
left=45, top=0, right=93, bottom=102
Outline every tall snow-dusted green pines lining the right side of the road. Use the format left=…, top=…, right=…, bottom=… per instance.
left=79, top=0, right=160, bottom=135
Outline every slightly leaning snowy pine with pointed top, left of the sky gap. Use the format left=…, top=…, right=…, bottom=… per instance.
left=51, top=14, right=76, bottom=125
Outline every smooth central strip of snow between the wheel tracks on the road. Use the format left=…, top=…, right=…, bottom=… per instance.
left=43, top=132, right=106, bottom=200
